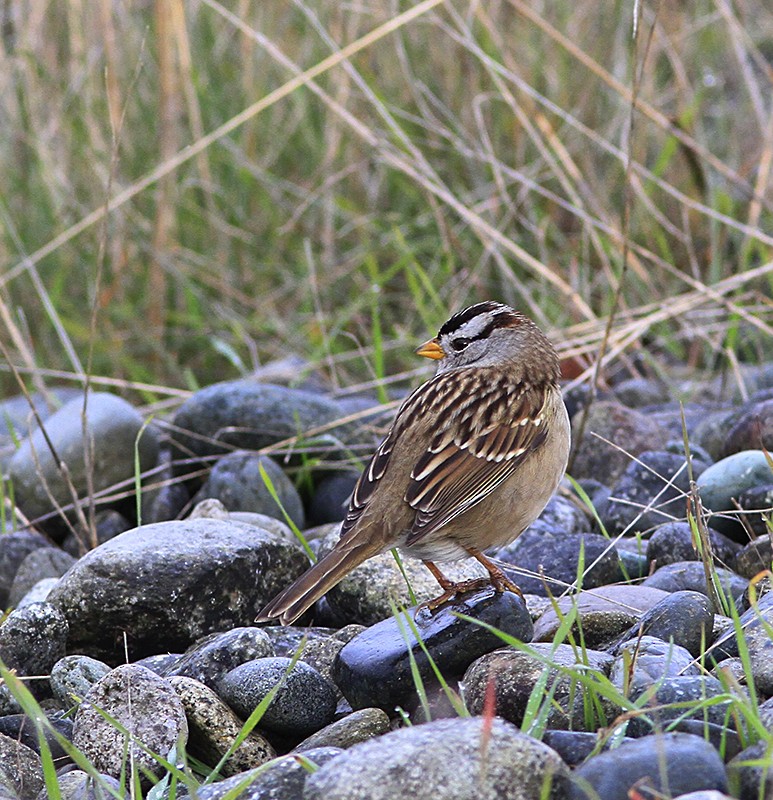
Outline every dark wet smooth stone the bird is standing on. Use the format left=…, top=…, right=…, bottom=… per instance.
left=333, top=589, right=532, bottom=712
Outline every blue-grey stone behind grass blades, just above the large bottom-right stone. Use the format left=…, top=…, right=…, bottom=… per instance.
left=626, top=675, right=732, bottom=736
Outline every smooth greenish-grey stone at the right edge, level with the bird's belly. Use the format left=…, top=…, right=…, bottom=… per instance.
left=697, top=450, right=773, bottom=541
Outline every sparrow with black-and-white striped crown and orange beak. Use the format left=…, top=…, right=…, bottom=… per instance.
left=256, top=300, right=570, bottom=625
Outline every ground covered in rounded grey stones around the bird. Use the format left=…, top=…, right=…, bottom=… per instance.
left=0, top=365, right=773, bottom=800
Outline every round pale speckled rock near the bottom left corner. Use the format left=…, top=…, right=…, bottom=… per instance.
left=73, top=664, right=188, bottom=778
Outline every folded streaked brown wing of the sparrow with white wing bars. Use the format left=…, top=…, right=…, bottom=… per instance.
left=405, top=372, right=547, bottom=545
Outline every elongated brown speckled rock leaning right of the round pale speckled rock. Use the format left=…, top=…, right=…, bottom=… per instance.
left=169, top=676, right=276, bottom=777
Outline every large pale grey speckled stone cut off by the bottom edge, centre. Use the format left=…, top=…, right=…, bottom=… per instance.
left=303, top=718, right=569, bottom=800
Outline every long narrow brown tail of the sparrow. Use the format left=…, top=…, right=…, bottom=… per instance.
left=255, top=546, right=375, bottom=625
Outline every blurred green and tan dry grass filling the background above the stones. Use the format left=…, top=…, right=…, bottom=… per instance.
left=0, top=0, right=773, bottom=400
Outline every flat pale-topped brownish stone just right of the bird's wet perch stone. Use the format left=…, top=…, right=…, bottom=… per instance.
left=534, top=586, right=667, bottom=647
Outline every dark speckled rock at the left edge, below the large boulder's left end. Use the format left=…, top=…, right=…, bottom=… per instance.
left=0, top=603, right=68, bottom=694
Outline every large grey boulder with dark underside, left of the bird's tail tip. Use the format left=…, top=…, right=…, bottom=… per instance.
left=50, top=519, right=308, bottom=662
